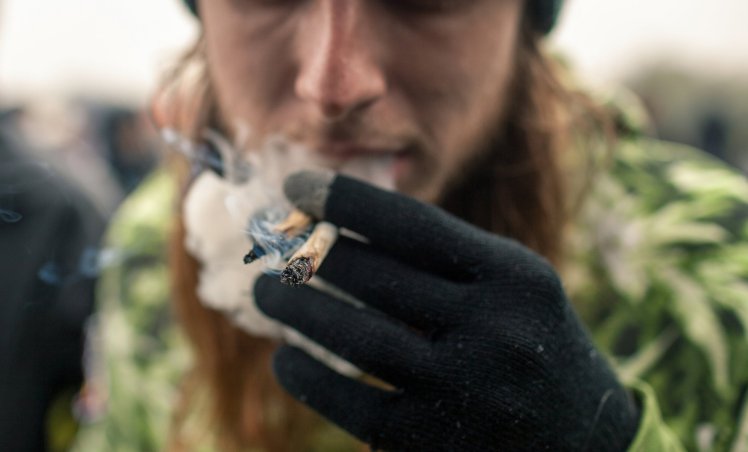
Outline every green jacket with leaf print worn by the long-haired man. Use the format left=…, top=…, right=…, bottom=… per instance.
left=77, top=129, right=748, bottom=451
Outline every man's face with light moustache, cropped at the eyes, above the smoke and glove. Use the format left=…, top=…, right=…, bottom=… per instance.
left=200, top=0, right=523, bottom=202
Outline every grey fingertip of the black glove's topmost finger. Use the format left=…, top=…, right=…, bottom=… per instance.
left=283, top=170, right=335, bottom=219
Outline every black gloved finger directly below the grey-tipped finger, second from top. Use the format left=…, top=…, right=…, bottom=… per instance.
left=317, top=237, right=464, bottom=330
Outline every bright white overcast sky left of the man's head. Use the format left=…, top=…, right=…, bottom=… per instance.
left=0, top=0, right=197, bottom=105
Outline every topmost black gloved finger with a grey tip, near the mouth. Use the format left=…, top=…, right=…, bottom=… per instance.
left=284, top=171, right=488, bottom=278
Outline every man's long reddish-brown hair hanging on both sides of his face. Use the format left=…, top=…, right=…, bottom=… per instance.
left=157, top=14, right=609, bottom=451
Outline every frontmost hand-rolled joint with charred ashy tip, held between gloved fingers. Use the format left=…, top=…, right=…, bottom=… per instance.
left=281, top=221, right=338, bottom=286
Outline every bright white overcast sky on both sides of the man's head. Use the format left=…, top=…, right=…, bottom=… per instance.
left=0, top=0, right=748, bottom=103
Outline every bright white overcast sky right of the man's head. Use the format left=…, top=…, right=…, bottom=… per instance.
left=552, top=0, right=748, bottom=84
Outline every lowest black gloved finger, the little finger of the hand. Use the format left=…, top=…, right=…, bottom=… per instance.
left=273, top=346, right=400, bottom=448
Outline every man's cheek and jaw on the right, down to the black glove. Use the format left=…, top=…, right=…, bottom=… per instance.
left=398, top=16, right=517, bottom=201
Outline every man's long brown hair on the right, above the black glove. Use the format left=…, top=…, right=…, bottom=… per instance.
left=441, top=22, right=614, bottom=269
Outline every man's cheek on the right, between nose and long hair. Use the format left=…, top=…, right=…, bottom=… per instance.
left=400, top=12, right=519, bottom=142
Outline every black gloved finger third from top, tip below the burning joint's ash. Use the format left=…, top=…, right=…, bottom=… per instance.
left=255, top=276, right=433, bottom=387
